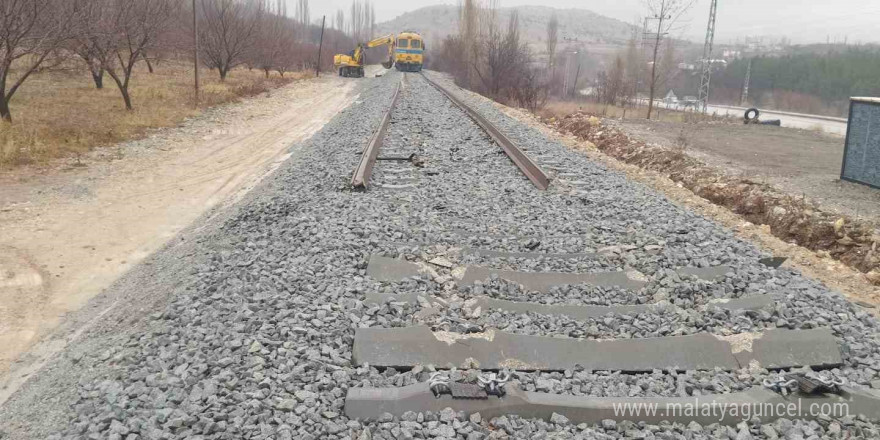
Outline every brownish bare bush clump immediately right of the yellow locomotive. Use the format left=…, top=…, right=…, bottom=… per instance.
left=431, top=0, right=549, bottom=109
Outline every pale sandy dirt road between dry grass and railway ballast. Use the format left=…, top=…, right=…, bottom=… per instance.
left=0, top=71, right=355, bottom=403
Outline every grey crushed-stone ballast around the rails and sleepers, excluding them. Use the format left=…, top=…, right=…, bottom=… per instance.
left=0, top=72, right=880, bottom=440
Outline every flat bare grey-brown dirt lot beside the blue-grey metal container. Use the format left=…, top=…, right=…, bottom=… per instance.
left=607, top=120, right=880, bottom=224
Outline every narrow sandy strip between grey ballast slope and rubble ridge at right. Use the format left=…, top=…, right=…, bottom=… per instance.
left=497, top=104, right=880, bottom=314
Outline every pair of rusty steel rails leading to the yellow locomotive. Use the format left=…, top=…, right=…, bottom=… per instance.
left=351, top=73, right=551, bottom=190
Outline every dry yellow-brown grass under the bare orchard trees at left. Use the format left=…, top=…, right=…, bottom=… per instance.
left=0, top=61, right=307, bottom=168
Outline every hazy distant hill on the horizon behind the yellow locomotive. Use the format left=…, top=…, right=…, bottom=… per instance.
left=377, top=5, right=633, bottom=52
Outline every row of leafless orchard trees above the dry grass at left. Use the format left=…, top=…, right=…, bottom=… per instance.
left=0, top=0, right=375, bottom=122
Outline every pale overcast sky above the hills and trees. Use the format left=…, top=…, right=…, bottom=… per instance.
left=300, top=0, right=880, bottom=43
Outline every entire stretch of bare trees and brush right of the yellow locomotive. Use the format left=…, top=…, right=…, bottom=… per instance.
left=431, top=0, right=693, bottom=113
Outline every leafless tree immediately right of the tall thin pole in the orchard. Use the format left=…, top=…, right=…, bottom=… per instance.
left=199, top=0, right=265, bottom=81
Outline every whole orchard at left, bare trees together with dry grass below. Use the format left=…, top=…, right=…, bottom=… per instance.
left=0, top=0, right=375, bottom=168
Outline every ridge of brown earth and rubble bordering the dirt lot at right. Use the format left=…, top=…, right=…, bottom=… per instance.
left=541, top=108, right=880, bottom=285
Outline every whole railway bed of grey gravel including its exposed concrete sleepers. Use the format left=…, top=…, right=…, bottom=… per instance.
left=12, top=72, right=880, bottom=440
